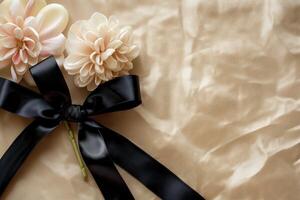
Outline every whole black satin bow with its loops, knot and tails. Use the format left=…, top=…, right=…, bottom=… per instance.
left=0, top=57, right=204, bottom=200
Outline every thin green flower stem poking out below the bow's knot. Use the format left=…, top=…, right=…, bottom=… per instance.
left=64, top=121, right=88, bottom=181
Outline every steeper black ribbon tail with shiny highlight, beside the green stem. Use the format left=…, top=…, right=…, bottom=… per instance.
left=78, top=121, right=134, bottom=200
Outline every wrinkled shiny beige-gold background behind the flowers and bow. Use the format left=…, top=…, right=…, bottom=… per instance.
left=0, top=0, right=300, bottom=200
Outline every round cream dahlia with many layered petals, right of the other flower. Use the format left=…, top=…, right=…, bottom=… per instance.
left=64, top=13, right=139, bottom=91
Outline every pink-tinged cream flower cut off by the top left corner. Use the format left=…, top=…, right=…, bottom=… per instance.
left=0, top=0, right=68, bottom=83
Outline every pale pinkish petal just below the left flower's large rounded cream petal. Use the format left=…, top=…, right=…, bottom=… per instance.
left=41, top=34, right=66, bottom=55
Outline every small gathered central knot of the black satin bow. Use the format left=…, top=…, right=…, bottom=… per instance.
left=62, top=105, right=88, bottom=122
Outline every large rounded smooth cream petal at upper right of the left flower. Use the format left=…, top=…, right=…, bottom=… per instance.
left=36, top=4, right=69, bottom=40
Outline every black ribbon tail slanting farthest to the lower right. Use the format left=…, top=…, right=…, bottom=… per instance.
left=83, top=122, right=205, bottom=200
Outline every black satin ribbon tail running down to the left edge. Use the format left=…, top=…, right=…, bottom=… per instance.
left=0, top=120, right=56, bottom=197
